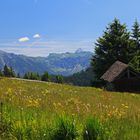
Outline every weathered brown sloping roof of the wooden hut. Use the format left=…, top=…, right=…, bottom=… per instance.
left=101, top=61, right=129, bottom=82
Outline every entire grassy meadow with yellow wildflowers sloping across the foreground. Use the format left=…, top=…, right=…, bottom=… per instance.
left=0, top=78, right=140, bottom=140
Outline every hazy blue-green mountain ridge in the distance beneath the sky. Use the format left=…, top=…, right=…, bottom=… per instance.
left=0, top=49, right=92, bottom=76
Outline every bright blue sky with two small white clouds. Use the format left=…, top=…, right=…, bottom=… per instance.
left=0, top=0, right=140, bottom=56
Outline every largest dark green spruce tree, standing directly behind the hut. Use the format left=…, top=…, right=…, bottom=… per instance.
left=91, top=19, right=131, bottom=79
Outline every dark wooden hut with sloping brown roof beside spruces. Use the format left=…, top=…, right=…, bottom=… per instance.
left=101, top=61, right=140, bottom=92
